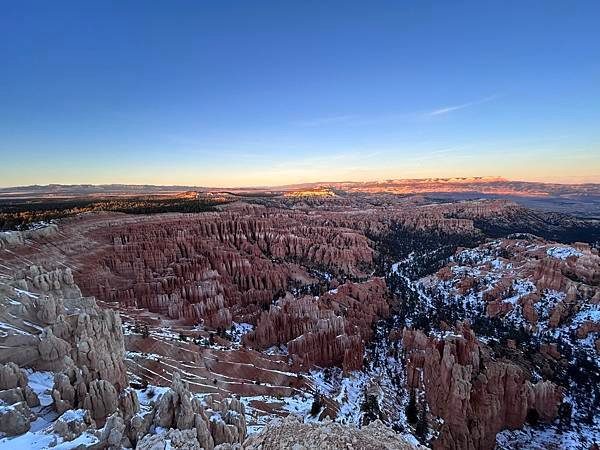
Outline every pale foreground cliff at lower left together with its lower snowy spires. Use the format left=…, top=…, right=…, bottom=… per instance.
left=0, top=253, right=246, bottom=450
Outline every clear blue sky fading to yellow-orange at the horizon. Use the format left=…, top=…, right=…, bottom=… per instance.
left=0, top=0, right=600, bottom=187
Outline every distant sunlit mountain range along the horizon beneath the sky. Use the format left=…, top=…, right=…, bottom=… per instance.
left=0, top=177, right=600, bottom=217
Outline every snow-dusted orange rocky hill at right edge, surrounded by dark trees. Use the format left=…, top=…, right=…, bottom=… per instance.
left=431, top=235, right=600, bottom=354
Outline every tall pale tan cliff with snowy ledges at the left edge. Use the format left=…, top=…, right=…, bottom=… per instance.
left=0, top=265, right=129, bottom=429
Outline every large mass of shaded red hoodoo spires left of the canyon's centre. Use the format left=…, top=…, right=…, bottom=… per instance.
left=71, top=208, right=373, bottom=328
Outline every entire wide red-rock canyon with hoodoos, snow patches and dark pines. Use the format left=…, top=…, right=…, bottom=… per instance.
left=0, top=194, right=600, bottom=449
